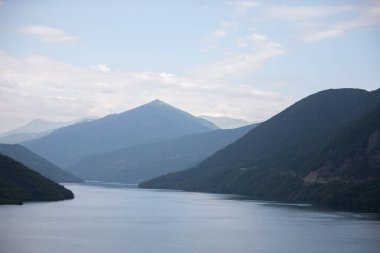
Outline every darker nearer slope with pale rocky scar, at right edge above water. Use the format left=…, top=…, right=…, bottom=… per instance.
left=291, top=103, right=380, bottom=212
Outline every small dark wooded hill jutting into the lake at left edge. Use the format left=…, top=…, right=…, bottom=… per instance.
left=0, top=155, right=74, bottom=204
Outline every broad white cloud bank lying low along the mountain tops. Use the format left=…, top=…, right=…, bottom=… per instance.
left=0, top=51, right=293, bottom=131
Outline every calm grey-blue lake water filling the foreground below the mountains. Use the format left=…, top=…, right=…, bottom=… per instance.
left=0, top=184, right=380, bottom=253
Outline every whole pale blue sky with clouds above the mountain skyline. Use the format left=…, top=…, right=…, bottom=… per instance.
left=0, top=0, right=380, bottom=132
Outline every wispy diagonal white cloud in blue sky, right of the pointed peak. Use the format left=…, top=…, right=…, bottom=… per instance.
left=190, top=33, right=286, bottom=79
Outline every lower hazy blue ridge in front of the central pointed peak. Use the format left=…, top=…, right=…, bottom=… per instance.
left=67, top=125, right=255, bottom=183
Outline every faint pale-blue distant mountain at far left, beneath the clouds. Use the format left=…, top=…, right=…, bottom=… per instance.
left=0, top=118, right=94, bottom=144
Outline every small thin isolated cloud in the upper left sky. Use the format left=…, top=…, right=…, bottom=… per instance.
left=21, top=25, right=79, bottom=43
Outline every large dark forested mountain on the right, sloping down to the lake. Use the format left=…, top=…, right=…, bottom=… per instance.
left=141, top=89, right=380, bottom=211
